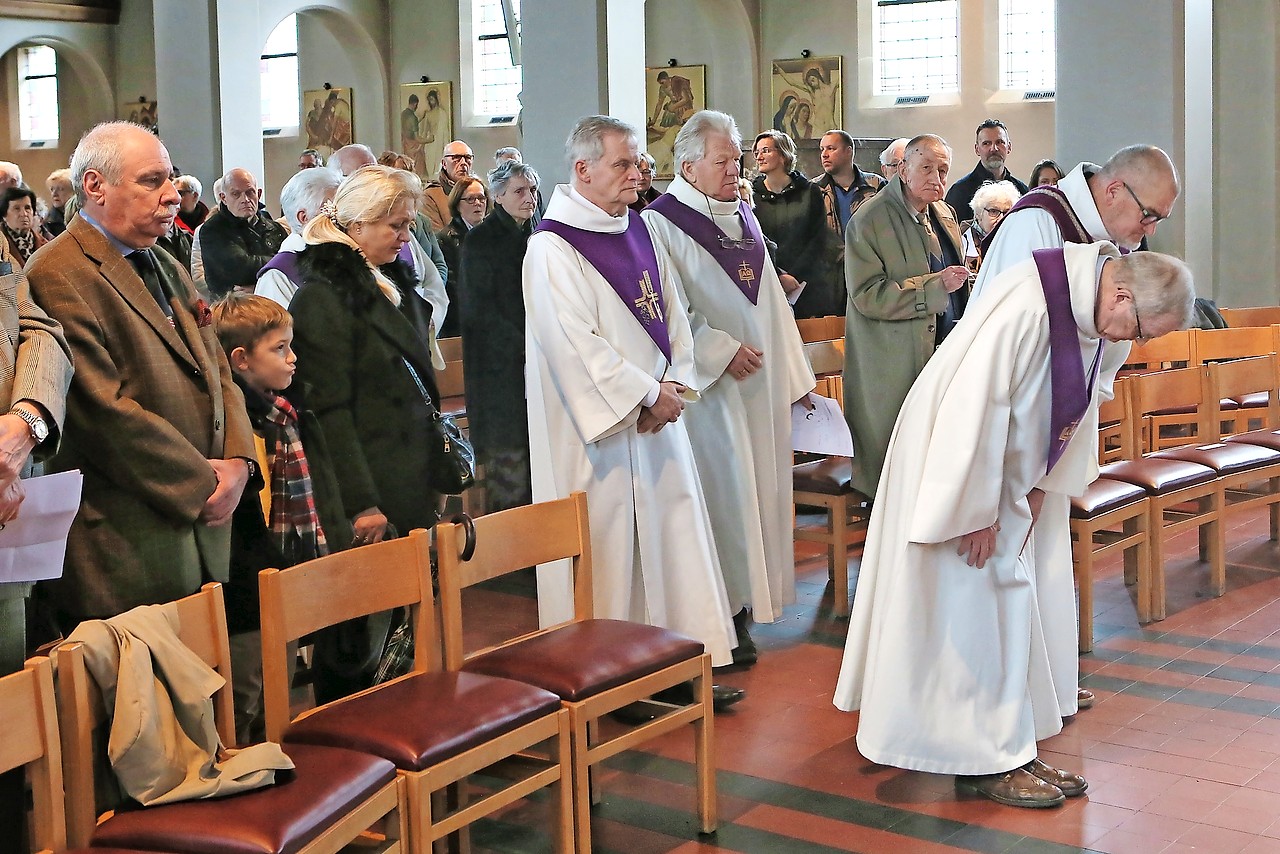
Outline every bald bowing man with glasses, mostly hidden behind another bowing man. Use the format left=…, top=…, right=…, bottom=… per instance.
left=973, top=145, right=1179, bottom=716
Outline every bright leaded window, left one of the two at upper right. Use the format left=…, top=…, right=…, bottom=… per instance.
left=874, top=0, right=960, bottom=95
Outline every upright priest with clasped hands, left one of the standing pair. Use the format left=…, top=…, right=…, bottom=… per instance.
left=524, top=115, right=742, bottom=708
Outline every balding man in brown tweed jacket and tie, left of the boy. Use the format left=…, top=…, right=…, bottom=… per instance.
left=27, top=122, right=259, bottom=630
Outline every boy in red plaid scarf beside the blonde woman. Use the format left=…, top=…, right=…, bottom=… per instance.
left=214, top=291, right=352, bottom=744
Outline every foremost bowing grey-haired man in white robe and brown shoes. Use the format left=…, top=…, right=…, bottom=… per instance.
left=835, top=242, right=1194, bottom=807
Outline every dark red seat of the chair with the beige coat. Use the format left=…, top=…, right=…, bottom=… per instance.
left=93, top=744, right=396, bottom=854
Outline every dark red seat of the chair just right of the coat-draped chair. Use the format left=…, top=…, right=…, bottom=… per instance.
left=284, top=672, right=561, bottom=771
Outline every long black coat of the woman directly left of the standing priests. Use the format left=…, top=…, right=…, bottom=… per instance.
left=461, top=207, right=531, bottom=457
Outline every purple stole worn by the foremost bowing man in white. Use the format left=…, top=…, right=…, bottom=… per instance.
left=1032, top=250, right=1106, bottom=474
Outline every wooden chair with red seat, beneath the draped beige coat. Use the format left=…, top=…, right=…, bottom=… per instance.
left=54, top=584, right=404, bottom=854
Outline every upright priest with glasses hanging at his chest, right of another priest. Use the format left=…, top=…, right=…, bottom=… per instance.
left=641, top=110, right=814, bottom=665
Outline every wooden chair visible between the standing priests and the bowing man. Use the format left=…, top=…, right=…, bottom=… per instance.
left=791, top=376, right=870, bottom=617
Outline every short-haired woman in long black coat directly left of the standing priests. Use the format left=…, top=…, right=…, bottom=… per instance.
left=461, top=160, right=538, bottom=511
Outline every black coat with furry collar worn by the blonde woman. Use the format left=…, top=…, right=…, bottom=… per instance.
left=289, top=243, right=439, bottom=534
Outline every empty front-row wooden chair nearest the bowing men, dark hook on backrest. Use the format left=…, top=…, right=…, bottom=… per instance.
left=436, top=492, right=718, bottom=854
